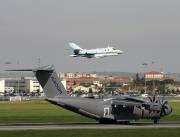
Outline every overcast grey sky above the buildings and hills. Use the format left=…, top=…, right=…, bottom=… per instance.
left=0, top=0, right=180, bottom=73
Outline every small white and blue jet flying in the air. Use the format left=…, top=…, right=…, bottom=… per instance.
left=69, top=43, right=123, bottom=58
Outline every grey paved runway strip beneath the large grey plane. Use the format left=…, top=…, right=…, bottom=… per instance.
left=0, top=122, right=180, bottom=131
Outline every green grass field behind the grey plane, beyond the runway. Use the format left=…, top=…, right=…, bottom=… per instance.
left=0, top=101, right=180, bottom=123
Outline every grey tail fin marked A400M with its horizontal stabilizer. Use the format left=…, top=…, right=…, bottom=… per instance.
left=6, top=65, right=68, bottom=98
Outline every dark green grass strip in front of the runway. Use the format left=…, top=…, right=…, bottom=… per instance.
left=0, top=128, right=180, bottom=137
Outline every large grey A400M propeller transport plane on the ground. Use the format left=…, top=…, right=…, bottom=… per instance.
left=9, top=65, right=172, bottom=124
